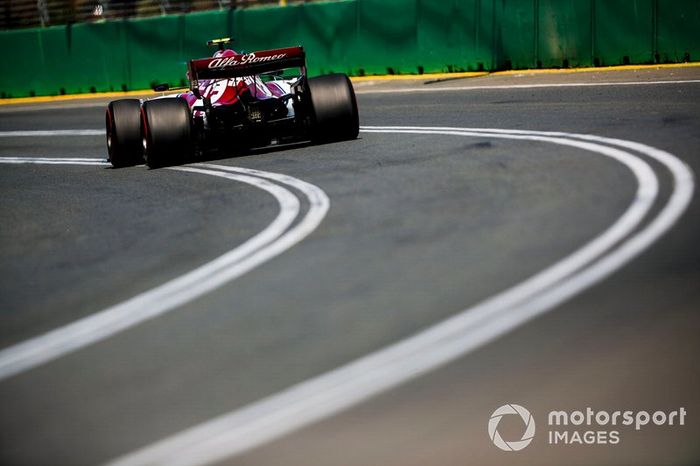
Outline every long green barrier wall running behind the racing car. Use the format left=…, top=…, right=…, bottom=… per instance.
left=0, top=0, right=700, bottom=97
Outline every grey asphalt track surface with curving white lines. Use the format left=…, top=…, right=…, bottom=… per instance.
left=0, top=68, right=700, bottom=465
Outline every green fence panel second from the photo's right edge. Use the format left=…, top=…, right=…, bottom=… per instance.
left=594, top=0, right=652, bottom=66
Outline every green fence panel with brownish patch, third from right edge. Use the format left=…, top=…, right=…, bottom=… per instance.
left=535, top=0, right=593, bottom=68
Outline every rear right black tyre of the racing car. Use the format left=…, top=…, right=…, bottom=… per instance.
left=309, top=74, right=360, bottom=142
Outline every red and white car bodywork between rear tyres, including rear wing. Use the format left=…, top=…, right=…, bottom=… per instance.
left=178, top=47, right=311, bottom=148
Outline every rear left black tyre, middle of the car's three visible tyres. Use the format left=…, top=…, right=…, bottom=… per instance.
left=141, top=98, right=192, bottom=168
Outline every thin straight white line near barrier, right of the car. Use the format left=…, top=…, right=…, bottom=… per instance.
left=355, top=79, right=700, bottom=94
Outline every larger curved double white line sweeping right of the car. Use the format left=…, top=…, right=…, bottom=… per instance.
left=109, top=127, right=693, bottom=466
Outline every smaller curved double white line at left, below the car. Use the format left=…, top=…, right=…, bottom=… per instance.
left=0, top=159, right=329, bottom=380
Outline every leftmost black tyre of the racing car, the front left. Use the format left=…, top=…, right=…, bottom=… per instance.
left=105, top=99, right=143, bottom=168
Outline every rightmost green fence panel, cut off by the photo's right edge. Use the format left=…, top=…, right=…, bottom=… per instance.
left=655, top=0, right=700, bottom=63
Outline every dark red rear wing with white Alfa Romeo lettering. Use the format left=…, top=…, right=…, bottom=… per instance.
left=188, top=47, right=306, bottom=94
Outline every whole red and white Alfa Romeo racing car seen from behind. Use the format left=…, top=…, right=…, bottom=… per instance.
left=106, top=38, right=359, bottom=168
